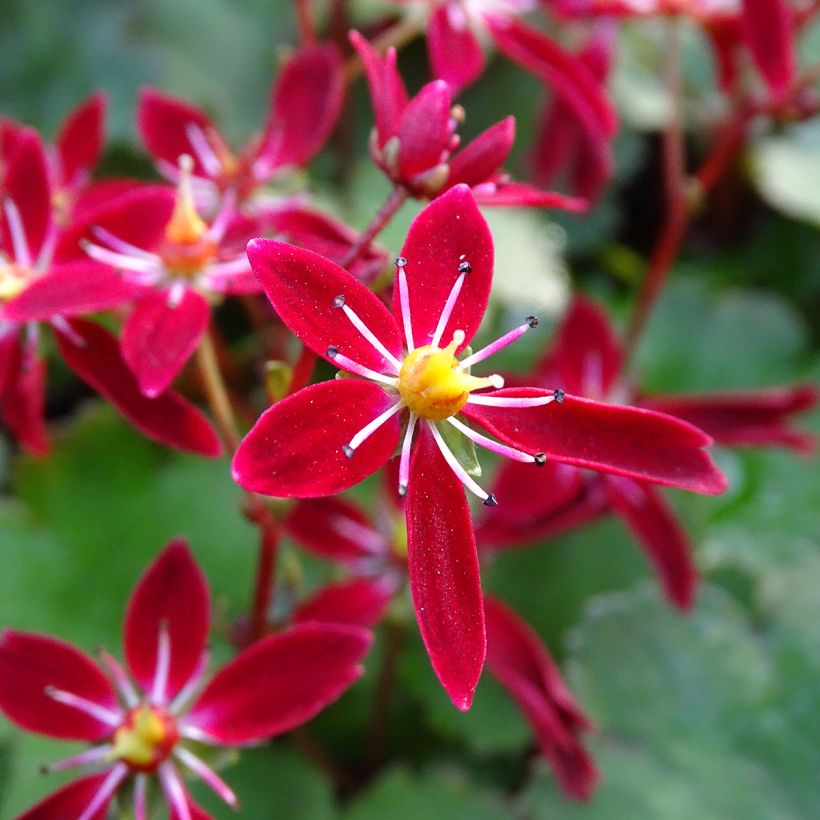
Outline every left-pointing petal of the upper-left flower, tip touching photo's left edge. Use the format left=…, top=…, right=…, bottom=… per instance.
left=0, top=259, right=139, bottom=322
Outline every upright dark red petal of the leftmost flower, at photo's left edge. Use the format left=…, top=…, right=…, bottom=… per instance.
left=0, top=128, right=51, bottom=262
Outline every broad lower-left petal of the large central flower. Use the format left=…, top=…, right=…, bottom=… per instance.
left=232, top=379, right=399, bottom=498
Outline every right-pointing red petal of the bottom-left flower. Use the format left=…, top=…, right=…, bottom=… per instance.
left=185, top=623, right=372, bottom=745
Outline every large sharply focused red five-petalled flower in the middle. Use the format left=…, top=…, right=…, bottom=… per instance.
left=233, top=185, right=725, bottom=709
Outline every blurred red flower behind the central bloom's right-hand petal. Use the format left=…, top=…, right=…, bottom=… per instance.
left=479, top=298, right=818, bottom=609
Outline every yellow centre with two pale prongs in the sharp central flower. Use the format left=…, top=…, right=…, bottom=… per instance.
left=398, top=331, right=503, bottom=421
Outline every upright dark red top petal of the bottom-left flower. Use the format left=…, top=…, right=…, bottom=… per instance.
left=125, top=540, right=210, bottom=702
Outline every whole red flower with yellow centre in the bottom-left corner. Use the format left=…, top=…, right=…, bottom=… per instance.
left=0, top=541, right=370, bottom=820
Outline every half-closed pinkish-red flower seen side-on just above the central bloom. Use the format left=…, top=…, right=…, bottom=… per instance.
left=350, top=31, right=586, bottom=211
